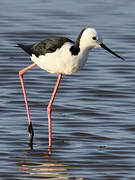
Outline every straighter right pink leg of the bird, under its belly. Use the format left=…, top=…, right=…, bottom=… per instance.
left=47, top=74, right=62, bottom=149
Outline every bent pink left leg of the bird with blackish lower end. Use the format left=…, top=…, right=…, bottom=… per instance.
left=19, top=63, right=36, bottom=142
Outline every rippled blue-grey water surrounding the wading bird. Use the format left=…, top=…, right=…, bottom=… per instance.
left=0, top=0, right=135, bottom=180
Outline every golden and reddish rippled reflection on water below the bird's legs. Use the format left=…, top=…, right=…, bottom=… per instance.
left=17, top=150, right=70, bottom=180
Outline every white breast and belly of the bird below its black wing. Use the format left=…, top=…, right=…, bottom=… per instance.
left=31, top=43, right=88, bottom=74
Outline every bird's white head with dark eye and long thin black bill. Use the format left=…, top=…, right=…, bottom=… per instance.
left=79, top=28, right=125, bottom=60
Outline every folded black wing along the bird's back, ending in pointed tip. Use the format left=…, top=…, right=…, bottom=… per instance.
left=17, top=37, right=74, bottom=57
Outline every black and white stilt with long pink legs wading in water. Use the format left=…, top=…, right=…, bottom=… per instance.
left=18, top=28, right=124, bottom=148
